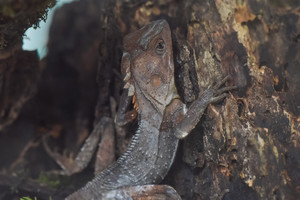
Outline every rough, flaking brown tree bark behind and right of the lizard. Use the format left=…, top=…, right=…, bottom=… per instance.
left=93, top=0, right=300, bottom=199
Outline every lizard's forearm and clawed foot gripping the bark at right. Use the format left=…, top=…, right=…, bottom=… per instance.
left=175, top=76, right=237, bottom=139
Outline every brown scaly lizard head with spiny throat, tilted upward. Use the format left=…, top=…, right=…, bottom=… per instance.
left=121, top=20, right=178, bottom=113
